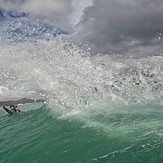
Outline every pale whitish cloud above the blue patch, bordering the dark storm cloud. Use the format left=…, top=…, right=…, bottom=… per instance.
left=0, top=0, right=91, bottom=30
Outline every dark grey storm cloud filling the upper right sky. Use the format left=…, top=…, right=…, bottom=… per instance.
left=74, top=0, right=163, bottom=53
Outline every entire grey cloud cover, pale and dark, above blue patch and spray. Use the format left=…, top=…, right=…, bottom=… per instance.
left=0, top=0, right=163, bottom=56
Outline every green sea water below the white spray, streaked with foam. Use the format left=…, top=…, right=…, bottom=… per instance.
left=0, top=105, right=163, bottom=163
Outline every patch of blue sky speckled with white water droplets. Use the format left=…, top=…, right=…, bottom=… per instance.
left=0, top=9, right=68, bottom=42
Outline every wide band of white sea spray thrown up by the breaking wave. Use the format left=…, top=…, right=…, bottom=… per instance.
left=0, top=39, right=163, bottom=110
